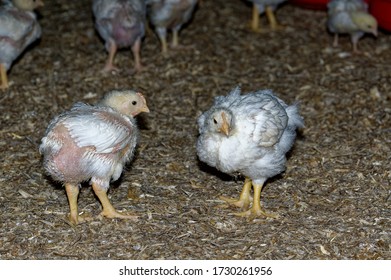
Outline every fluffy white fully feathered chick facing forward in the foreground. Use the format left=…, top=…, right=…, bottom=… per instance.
left=197, top=87, right=303, bottom=217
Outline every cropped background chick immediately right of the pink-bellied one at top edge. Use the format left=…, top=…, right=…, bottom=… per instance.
left=147, top=0, right=198, bottom=53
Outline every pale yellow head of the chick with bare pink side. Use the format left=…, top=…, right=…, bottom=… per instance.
left=100, top=90, right=149, bottom=117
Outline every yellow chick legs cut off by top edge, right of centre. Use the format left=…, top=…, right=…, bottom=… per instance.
left=249, top=0, right=286, bottom=32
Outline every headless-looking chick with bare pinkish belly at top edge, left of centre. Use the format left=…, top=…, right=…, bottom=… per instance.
left=92, top=0, right=146, bottom=72
